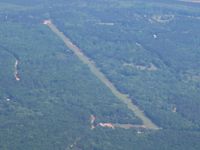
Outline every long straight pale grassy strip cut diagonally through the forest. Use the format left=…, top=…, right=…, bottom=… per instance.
left=45, top=21, right=160, bottom=130
